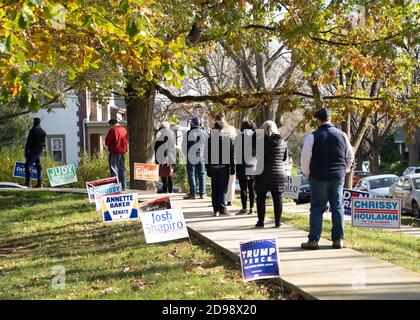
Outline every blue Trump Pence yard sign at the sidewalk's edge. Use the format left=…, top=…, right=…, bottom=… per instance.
left=239, top=238, right=280, bottom=281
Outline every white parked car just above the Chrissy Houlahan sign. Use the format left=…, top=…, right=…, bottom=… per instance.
left=354, top=174, right=398, bottom=198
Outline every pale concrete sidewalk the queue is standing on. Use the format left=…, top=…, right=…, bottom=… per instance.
left=172, top=196, right=420, bottom=300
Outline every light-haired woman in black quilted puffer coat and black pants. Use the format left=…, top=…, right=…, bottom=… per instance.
left=255, top=120, right=287, bottom=228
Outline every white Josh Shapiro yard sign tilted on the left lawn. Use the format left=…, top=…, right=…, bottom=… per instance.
left=140, top=209, right=189, bottom=243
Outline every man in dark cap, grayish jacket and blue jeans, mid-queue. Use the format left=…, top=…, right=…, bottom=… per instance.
left=185, top=117, right=208, bottom=199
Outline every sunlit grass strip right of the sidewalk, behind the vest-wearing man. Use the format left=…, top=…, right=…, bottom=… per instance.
left=267, top=208, right=420, bottom=272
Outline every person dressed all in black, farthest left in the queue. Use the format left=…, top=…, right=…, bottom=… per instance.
left=24, top=118, right=46, bottom=188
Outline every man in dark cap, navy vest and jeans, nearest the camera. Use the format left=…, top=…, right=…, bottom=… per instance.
left=301, top=108, right=354, bottom=250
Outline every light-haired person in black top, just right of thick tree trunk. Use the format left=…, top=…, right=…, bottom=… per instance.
left=155, top=121, right=175, bottom=193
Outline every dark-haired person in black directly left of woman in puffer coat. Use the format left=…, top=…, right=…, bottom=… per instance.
left=235, top=121, right=256, bottom=215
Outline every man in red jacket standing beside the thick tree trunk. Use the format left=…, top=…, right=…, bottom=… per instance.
left=105, top=119, right=128, bottom=190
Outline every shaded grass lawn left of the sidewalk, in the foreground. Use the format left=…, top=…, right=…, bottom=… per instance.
left=0, top=191, right=281, bottom=300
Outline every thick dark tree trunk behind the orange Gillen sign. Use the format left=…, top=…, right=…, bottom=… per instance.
left=126, top=83, right=155, bottom=190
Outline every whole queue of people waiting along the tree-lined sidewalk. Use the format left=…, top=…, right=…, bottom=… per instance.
left=25, top=108, right=354, bottom=250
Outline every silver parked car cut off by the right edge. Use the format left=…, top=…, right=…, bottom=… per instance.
left=389, top=173, right=420, bottom=218
